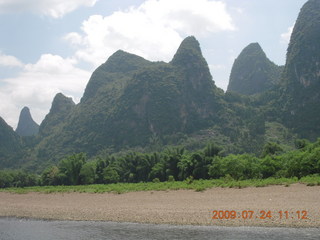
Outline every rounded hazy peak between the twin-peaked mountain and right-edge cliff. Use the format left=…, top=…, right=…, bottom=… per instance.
left=227, top=43, right=282, bottom=95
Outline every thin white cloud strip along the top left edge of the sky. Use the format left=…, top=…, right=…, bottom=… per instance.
left=0, top=0, right=98, bottom=18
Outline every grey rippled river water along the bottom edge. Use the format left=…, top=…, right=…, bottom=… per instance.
left=0, top=218, right=320, bottom=240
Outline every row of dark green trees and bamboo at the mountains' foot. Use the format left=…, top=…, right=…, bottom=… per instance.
left=0, top=139, right=320, bottom=188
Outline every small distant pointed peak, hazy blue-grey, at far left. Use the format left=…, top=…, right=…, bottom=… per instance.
left=16, top=107, right=39, bottom=137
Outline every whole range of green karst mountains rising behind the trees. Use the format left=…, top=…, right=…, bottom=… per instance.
left=0, top=0, right=320, bottom=168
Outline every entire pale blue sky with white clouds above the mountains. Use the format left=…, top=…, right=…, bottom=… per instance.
left=0, top=0, right=306, bottom=128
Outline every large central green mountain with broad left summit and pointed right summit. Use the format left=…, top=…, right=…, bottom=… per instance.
left=28, top=37, right=221, bottom=163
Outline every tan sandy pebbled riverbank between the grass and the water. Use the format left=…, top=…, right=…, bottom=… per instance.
left=0, top=184, right=320, bottom=227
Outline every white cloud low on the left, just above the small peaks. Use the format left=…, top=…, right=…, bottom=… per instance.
left=0, top=54, right=90, bottom=127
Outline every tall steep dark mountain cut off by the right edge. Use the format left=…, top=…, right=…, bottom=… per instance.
left=281, top=0, right=320, bottom=139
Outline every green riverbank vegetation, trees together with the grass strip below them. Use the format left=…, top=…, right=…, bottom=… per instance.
left=0, top=139, right=320, bottom=192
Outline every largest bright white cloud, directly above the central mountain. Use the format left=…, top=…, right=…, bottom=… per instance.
left=65, top=0, right=235, bottom=66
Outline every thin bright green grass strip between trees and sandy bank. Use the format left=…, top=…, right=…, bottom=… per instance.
left=0, top=175, right=320, bottom=194
